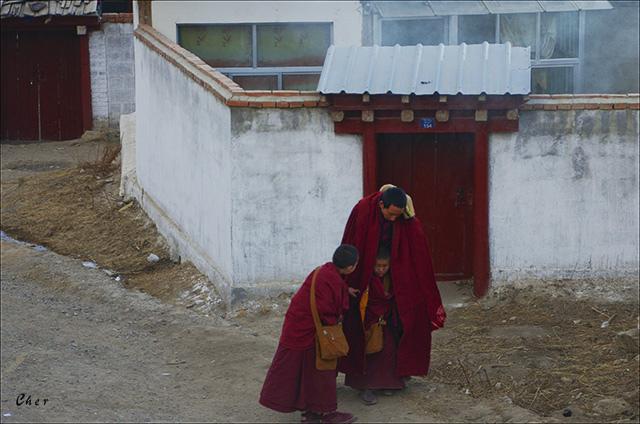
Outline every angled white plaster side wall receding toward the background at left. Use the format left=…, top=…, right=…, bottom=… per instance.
left=135, top=40, right=232, bottom=298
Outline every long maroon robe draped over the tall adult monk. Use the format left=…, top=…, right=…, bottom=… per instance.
left=338, top=192, right=446, bottom=377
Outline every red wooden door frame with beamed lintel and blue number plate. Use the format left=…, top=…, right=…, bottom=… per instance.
left=327, top=94, right=524, bottom=297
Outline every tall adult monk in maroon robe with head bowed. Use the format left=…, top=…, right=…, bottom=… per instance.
left=338, top=186, right=446, bottom=404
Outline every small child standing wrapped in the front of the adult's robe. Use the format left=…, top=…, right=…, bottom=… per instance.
left=344, top=247, right=405, bottom=405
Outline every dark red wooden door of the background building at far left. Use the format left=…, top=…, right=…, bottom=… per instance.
left=0, top=31, right=83, bottom=140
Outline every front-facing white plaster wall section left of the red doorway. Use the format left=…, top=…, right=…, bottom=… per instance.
left=231, top=108, right=362, bottom=288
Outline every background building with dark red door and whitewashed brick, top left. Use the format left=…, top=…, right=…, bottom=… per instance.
left=0, top=0, right=135, bottom=140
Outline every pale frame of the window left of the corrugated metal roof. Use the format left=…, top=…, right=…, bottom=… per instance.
left=176, top=21, right=334, bottom=90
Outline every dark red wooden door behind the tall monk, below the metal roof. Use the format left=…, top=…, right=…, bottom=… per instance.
left=377, top=134, right=473, bottom=280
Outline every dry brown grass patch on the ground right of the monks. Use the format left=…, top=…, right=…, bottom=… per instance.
left=431, top=293, right=639, bottom=421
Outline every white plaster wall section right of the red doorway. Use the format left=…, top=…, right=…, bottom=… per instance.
left=489, top=110, right=639, bottom=282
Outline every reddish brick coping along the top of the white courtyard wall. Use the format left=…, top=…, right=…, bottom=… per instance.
left=135, top=24, right=640, bottom=110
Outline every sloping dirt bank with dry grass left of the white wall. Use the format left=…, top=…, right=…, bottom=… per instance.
left=1, top=137, right=223, bottom=316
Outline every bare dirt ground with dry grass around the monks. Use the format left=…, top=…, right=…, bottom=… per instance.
left=1, top=140, right=639, bottom=422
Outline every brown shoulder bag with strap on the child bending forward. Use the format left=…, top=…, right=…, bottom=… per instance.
left=310, top=268, right=349, bottom=370
